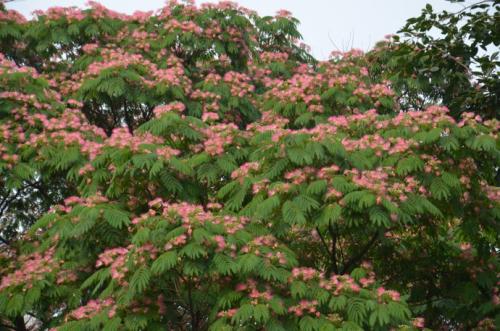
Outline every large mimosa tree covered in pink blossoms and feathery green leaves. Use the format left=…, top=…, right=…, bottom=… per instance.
left=0, top=1, right=500, bottom=331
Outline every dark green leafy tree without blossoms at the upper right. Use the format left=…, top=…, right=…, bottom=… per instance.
left=370, top=0, right=500, bottom=119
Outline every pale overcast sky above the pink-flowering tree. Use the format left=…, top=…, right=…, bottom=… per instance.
left=3, top=0, right=462, bottom=59
